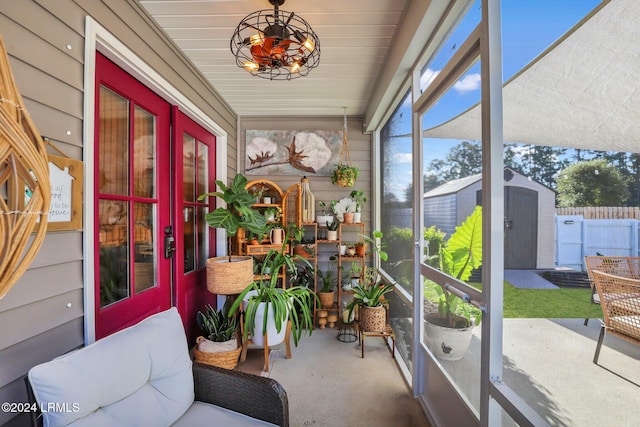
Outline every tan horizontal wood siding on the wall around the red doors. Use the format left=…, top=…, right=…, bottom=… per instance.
left=0, top=0, right=237, bottom=426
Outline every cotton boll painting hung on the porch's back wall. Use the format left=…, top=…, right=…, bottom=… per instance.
left=245, top=130, right=342, bottom=176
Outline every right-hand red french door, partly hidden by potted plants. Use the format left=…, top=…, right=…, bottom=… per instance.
left=173, top=107, right=216, bottom=342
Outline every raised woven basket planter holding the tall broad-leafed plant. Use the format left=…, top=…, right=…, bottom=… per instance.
left=207, top=256, right=253, bottom=295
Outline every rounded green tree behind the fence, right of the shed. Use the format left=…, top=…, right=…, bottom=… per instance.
left=557, top=159, right=629, bottom=207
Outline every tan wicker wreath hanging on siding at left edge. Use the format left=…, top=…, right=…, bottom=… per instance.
left=0, top=37, right=51, bottom=298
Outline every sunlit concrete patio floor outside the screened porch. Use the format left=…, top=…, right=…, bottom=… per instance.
left=442, top=319, right=640, bottom=427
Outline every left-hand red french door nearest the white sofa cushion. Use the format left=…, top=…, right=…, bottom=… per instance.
left=93, top=53, right=172, bottom=338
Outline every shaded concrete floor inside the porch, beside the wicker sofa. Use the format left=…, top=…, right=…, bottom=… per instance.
left=240, top=328, right=430, bottom=427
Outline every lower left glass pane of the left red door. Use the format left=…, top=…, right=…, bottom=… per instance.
left=98, top=200, right=129, bottom=307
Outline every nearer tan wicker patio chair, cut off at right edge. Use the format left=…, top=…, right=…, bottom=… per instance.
left=586, top=257, right=640, bottom=363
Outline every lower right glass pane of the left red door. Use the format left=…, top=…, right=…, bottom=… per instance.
left=133, top=203, right=156, bottom=293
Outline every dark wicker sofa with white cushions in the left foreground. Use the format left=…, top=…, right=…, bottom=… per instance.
left=26, top=308, right=289, bottom=427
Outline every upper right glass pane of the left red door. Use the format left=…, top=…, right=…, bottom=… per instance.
left=133, top=106, right=156, bottom=201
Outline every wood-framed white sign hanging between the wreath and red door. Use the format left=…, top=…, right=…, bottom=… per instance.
left=47, top=155, right=82, bottom=231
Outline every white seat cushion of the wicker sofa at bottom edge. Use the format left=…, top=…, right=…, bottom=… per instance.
left=173, top=402, right=276, bottom=427
